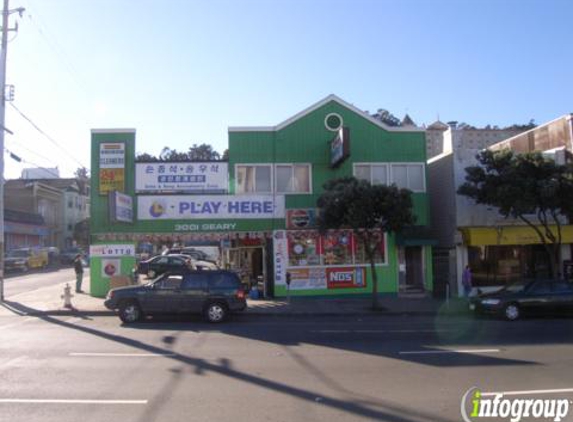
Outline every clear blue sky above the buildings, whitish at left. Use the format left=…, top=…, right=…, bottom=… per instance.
left=5, top=0, right=573, bottom=178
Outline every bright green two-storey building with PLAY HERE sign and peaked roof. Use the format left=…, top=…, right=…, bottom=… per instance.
left=91, top=95, right=432, bottom=297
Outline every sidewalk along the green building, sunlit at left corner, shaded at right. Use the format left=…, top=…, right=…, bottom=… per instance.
left=0, top=277, right=468, bottom=316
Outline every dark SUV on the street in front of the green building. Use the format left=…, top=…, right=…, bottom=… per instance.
left=104, top=270, right=247, bottom=323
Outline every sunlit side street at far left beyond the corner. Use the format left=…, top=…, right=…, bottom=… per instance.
left=4, top=268, right=76, bottom=299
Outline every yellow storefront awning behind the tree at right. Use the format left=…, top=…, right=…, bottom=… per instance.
left=459, top=225, right=573, bottom=246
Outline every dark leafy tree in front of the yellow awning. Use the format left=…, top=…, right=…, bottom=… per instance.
left=458, top=149, right=573, bottom=277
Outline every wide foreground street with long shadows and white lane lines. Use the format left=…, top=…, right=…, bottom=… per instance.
left=0, top=315, right=573, bottom=422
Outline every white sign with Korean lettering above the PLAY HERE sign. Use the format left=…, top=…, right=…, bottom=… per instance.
left=135, top=162, right=229, bottom=193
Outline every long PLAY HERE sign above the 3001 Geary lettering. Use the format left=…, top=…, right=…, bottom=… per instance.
left=137, top=195, right=285, bottom=220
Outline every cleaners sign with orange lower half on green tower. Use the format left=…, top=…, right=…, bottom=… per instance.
left=99, top=142, right=125, bottom=195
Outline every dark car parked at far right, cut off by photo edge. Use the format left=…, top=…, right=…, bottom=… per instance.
left=470, top=280, right=573, bottom=321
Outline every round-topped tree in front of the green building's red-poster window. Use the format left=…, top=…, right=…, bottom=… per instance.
left=317, top=177, right=416, bottom=309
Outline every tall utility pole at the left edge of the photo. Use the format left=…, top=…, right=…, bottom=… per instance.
left=0, top=0, right=24, bottom=303
